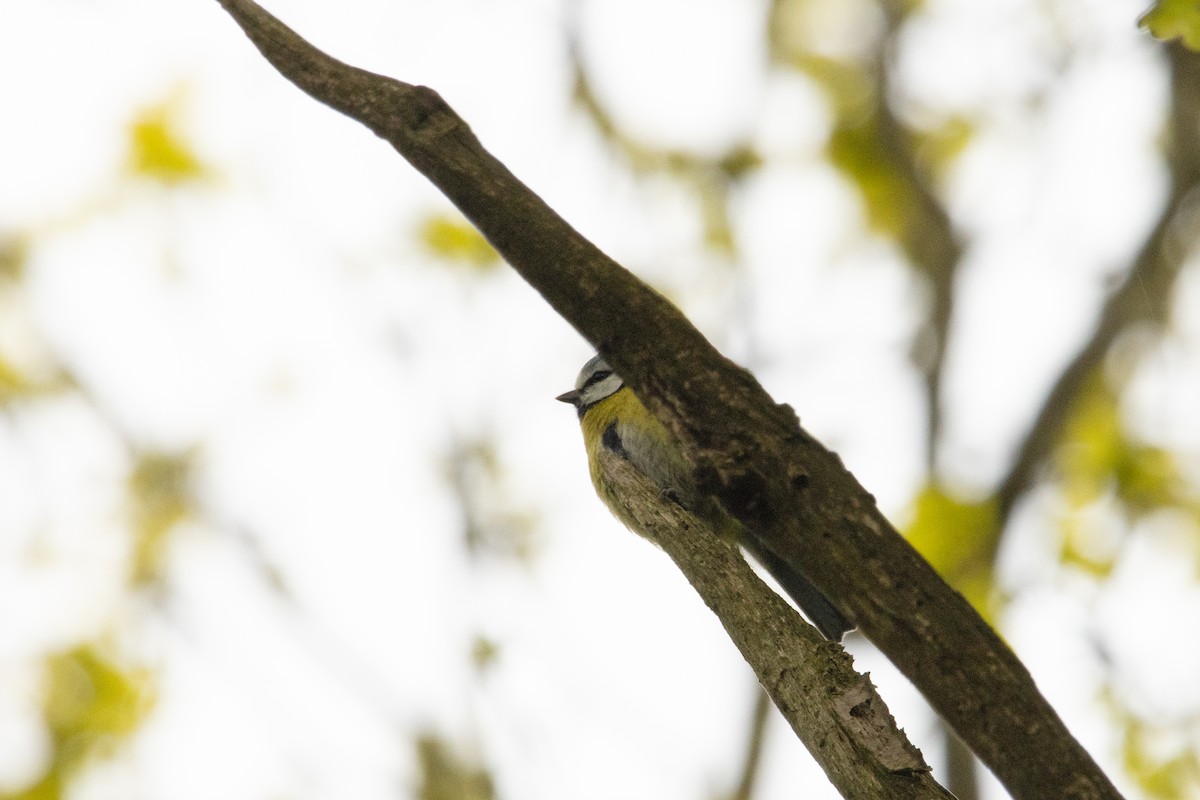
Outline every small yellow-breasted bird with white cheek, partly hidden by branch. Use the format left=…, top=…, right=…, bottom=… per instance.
left=556, top=355, right=853, bottom=642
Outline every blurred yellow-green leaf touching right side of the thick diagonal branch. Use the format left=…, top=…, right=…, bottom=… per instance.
left=905, top=485, right=1000, bottom=618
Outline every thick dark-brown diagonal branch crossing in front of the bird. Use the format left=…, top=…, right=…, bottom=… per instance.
left=213, top=0, right=1120, bottom=800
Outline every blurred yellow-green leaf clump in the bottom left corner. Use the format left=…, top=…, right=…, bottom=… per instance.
left=0, top=643, right=154, bottom=800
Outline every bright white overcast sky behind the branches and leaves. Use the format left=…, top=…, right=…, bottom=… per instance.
left=0, top=0, right=1200, bottom=800
